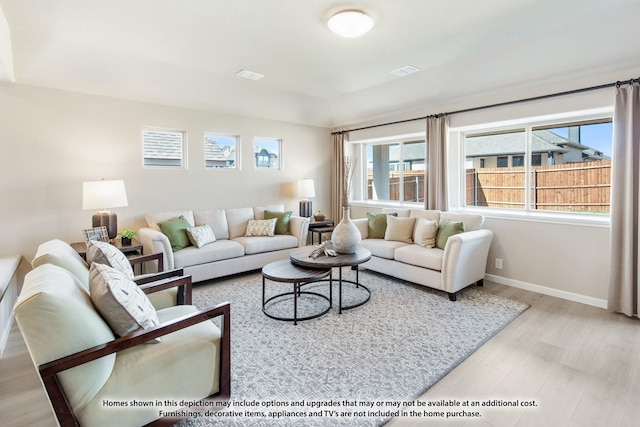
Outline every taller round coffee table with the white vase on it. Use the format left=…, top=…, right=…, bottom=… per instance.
left=289, top=246, right=371, bottom=313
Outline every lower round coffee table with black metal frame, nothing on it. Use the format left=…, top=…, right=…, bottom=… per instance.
left=262, top=260, right=331, bottom=325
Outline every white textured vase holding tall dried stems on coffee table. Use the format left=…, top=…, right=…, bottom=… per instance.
left=331, top=156, right=362, bottom=254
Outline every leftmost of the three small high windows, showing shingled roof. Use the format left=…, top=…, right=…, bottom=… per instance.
left=142, top=129, right=187, bottom=168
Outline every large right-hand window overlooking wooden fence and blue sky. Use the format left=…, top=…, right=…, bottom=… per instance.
left=464, top=118, right=612, bottom=213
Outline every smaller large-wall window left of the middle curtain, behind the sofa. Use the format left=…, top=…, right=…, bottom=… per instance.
left=364, top=140, right=426, bottom=202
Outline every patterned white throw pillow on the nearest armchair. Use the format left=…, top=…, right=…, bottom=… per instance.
left=89, top=263, right=160, bottom=342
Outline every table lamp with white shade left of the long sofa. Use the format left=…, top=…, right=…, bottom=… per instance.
left=82, top=179, right=128, bottom=239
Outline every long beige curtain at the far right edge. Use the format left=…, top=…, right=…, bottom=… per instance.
left=608, top=84, right=640, bottom=316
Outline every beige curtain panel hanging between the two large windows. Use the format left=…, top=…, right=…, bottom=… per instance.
left=424, top=116, right=449, bottom=211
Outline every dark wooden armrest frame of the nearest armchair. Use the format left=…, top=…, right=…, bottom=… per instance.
left=38, top=302, right=231, bottom=426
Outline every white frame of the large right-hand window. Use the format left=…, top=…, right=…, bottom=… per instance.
left=458, top=107, right=613, bottom=227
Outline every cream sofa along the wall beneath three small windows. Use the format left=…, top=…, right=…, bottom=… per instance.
left=138, top=204, right=309, bottom=282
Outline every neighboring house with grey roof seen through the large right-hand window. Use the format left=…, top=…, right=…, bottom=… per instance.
left=465, top=129, right=608, bottom=169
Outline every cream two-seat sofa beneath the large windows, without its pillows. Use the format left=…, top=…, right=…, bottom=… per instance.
left=353, top=209, right=493, bottom=301
